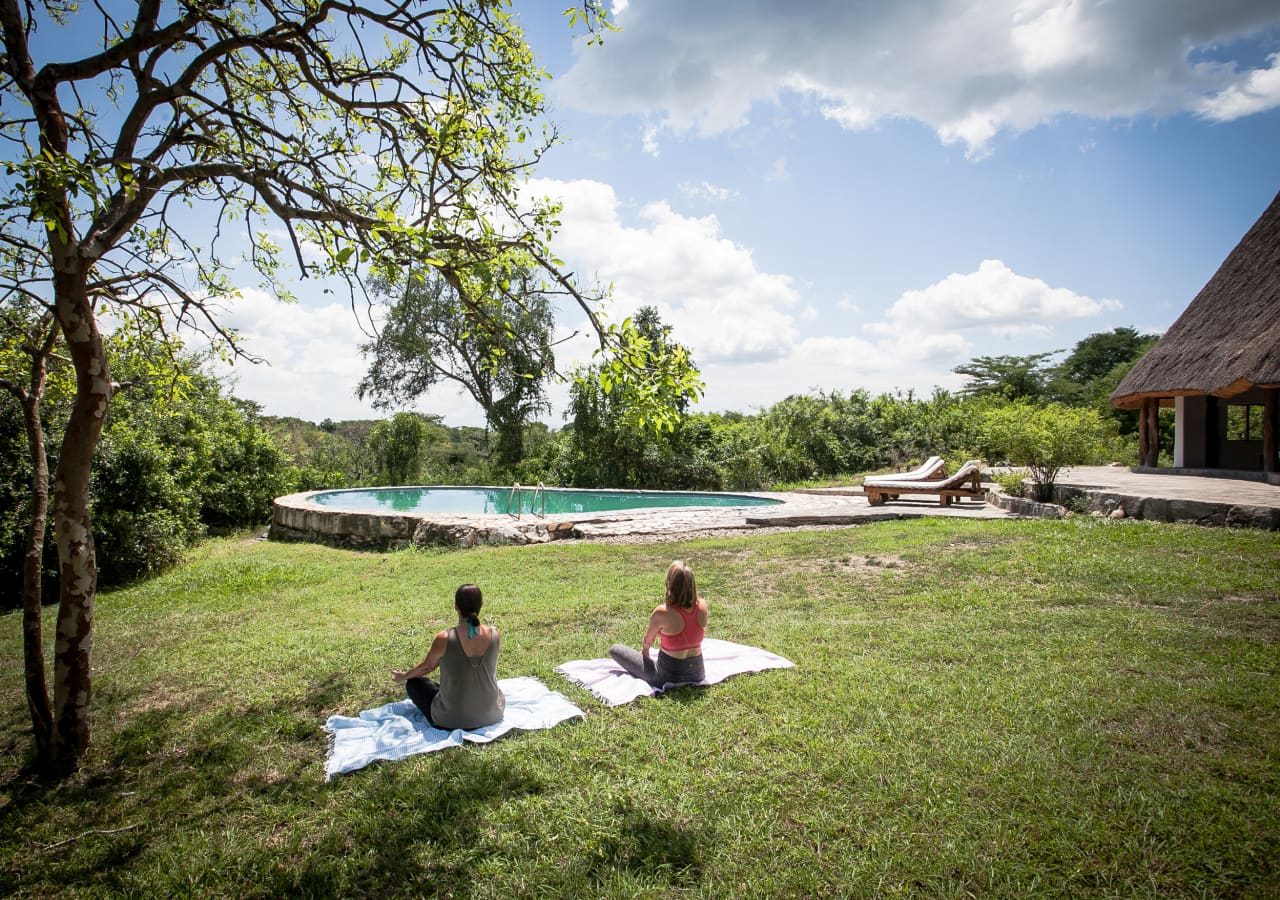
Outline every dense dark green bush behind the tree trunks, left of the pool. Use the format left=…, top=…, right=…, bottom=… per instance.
left=0, top=334, right=300, bottom=604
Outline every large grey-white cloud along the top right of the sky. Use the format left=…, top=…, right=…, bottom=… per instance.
left=554, top=0, right=1280, bottom=156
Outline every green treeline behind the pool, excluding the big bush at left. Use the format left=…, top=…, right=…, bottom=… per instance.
left=275, top=328, right=1156, bottom=490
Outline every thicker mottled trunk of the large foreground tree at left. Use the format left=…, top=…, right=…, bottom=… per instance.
left=52, top=267, right=111, bottom=773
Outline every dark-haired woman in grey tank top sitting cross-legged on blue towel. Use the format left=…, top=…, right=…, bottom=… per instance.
left=392, top=584, right=507, bottom=731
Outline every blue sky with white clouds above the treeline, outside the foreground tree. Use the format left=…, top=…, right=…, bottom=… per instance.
left=199, top=0, right=1280, bottom=426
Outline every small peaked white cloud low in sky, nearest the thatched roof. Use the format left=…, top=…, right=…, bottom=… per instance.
left=868, top=260, right=1120, bottom=337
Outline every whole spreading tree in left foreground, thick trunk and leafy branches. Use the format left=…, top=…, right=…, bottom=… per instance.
left=0, top=0, right=650, bottom=771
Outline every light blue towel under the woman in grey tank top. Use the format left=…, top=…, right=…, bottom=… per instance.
left=324, top=677, right=582, bottom=781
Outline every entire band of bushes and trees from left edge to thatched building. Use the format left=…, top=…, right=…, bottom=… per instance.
left=0, top=329, right=1167, bottom=606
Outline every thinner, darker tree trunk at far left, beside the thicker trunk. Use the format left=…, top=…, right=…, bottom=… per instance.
left=22, top=384, right=54, bottom=768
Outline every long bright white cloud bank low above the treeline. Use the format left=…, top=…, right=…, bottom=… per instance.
left=514, top=181, right=1120, bottom=419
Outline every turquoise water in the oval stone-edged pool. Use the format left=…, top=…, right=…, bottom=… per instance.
left=311, top=488, right=782, bottom=515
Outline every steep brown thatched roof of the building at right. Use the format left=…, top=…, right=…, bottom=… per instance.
left=1111, top=195, right=1280, bottom=407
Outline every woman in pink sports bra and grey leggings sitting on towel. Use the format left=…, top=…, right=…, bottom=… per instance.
left=609, top=559, right=708, bottom=687
